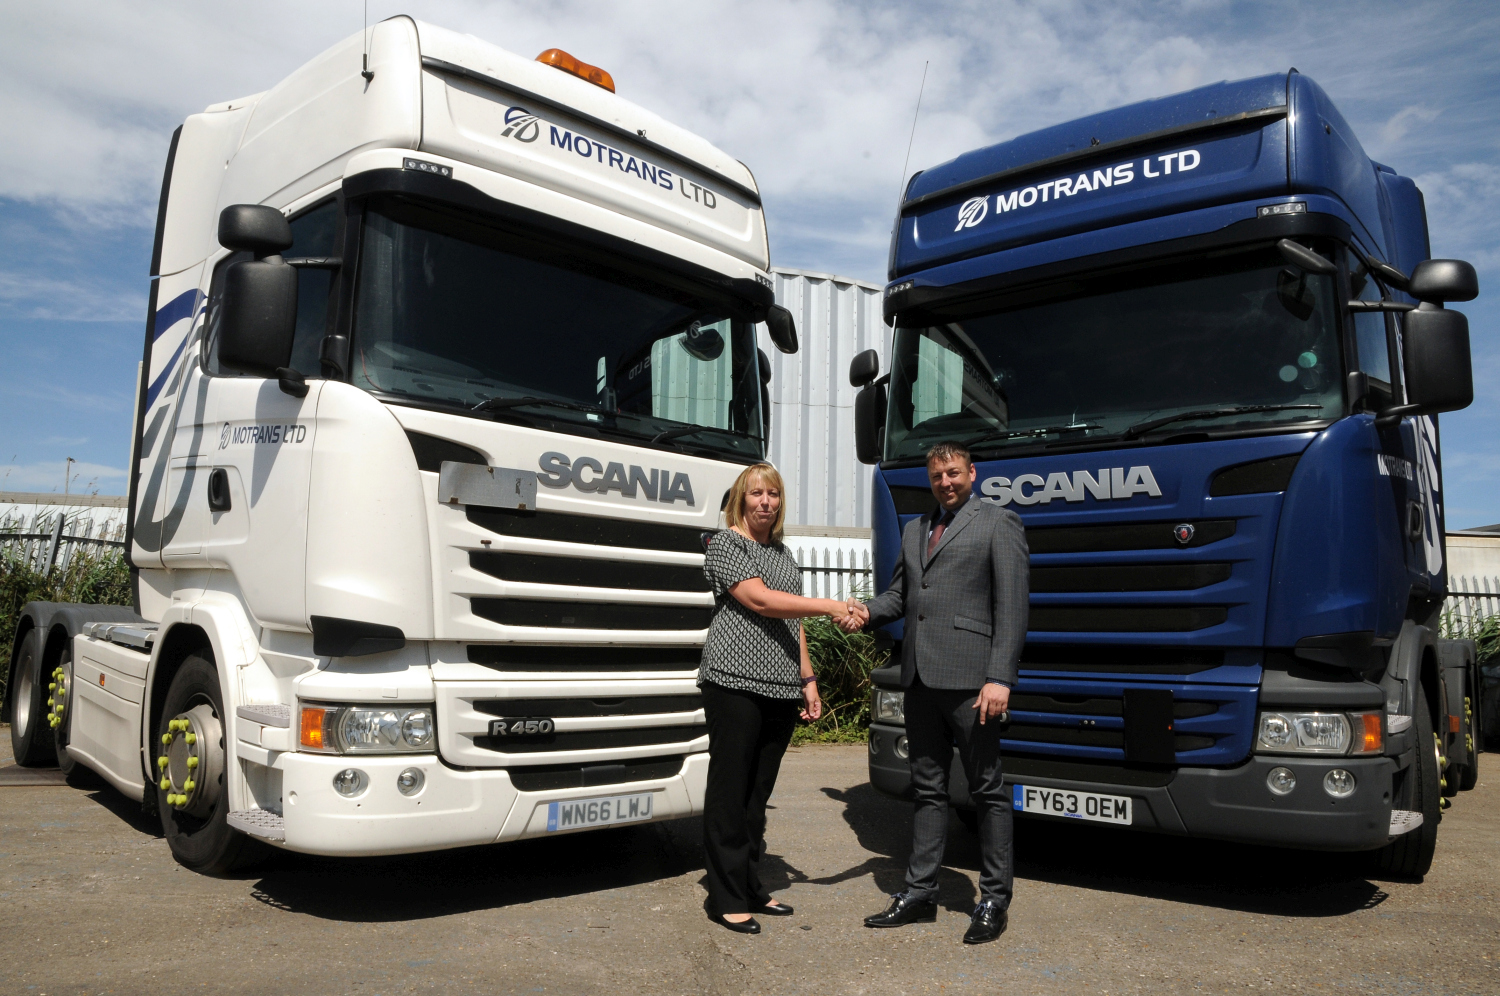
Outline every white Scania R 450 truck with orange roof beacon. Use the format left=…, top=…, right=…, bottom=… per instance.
left=5, top=17, right=797, bottom=873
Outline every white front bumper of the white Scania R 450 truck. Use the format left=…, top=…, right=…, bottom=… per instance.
left=272, top=752, right=708, bottom=857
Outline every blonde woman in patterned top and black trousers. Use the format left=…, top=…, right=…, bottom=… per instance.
left=698, top=464, right=849, bottom=933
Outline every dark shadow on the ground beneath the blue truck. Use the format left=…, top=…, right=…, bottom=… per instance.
left=813, top=785, right=1386, bottom=918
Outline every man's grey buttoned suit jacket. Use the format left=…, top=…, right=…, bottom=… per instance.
left=867, top=495, right=1031, bottom=692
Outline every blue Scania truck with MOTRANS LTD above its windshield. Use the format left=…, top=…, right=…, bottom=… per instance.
left=851, top=69, right=1479, bottom=876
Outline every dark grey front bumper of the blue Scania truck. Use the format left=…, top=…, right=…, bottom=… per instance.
left=870, top=725, right=1397, bottom=851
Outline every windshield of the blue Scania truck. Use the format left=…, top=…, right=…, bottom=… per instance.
left=885, top=249, right=1343, bottom=461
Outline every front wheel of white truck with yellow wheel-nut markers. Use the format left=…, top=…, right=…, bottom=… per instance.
left=152, top=651, right=264, bottom=875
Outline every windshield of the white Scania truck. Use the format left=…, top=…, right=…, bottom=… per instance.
left=351, top=198, right=764, bottom=459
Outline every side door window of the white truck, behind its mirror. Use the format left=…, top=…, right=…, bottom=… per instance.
left=203, top=201, right=339, bottom=377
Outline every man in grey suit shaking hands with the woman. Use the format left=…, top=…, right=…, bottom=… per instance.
left=845, top=443, right=1031, bottom=944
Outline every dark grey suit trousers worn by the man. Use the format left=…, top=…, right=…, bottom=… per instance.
left=906, top=678, right=1014, bottom=909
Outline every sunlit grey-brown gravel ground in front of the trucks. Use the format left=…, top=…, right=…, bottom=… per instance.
left=0, top=737, right=1500, bottom=996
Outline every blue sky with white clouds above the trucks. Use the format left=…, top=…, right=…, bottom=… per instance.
left=0, top=0, right=1500, bottom=528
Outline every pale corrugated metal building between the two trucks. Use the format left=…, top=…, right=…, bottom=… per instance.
left=761, top=269, right=891, bottom=537
